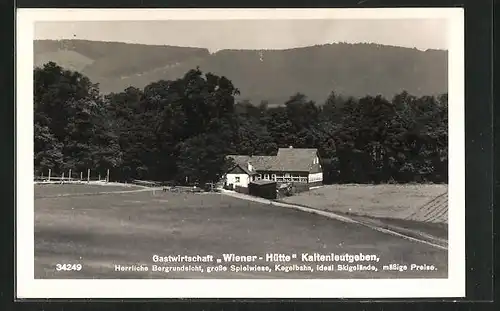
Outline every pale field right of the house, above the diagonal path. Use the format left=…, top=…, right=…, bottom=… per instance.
left=282, top=185, right=448, bottom=225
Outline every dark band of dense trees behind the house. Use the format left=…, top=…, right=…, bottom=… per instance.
left=34, top=63, right=448, bottom=183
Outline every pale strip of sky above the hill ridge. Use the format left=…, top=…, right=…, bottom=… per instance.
left=35, top=19, right=449, bottom=52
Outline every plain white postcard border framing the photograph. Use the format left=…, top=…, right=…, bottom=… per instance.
left=16, top=8, right=465, bottom=298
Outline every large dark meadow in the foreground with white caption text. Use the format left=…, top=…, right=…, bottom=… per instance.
left=34, top=185, right=448, bottom=278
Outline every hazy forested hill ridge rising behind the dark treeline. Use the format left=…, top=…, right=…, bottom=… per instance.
left=34, top=40, right=448, bottom=105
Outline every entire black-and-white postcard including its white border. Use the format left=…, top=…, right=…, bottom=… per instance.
left=17, top=8, right=465, bottom=298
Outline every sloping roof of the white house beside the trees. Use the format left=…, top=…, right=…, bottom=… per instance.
left=229, top=148, right=317, bottom=172
